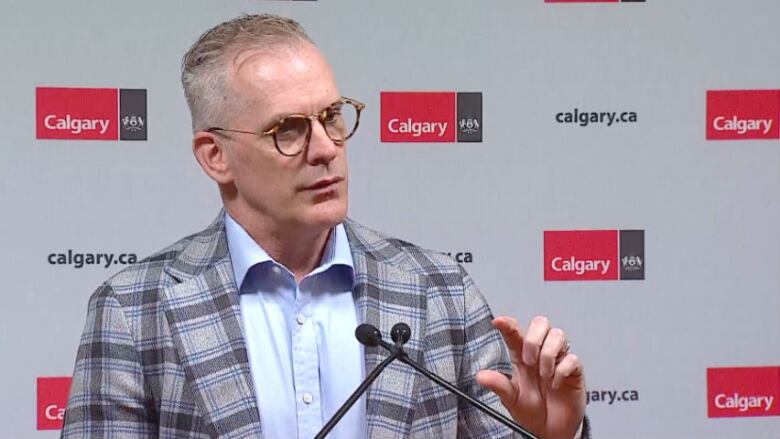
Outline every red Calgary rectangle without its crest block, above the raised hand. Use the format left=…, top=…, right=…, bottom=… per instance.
left=544, top=230, right=618, bottom=280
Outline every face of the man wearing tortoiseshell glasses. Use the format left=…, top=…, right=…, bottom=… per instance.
left=225, top=45, right=348, bottom=233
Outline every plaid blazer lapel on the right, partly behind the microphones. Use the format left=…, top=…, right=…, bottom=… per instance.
left=347, top=224, right=427, bottom=439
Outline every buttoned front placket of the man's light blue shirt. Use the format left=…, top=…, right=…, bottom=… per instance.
left=292, top=286, right=322, bottom=439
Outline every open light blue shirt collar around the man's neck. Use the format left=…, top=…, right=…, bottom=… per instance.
left=225, top=212, right=355, bottom=291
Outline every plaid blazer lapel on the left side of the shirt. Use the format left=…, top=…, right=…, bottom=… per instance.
left=161, top=215, right=261, bottom=438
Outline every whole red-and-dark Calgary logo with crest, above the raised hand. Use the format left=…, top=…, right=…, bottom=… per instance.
left=544, top=230, right=645, bottom=281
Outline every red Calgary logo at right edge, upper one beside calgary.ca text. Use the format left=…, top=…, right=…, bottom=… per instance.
left=707, top=90, right=780, bottom=140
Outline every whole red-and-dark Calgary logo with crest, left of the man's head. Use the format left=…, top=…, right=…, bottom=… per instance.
left=35, top=87, right=147, bottom=140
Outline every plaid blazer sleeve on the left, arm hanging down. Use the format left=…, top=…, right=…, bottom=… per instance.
left=61, top=284, right=157, bottom=439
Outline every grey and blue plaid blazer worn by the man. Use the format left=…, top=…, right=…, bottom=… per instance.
left=62, top=213, right=584, bottom=439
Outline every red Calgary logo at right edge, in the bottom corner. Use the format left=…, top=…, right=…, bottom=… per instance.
left=707, top=366, right=780, bottom=418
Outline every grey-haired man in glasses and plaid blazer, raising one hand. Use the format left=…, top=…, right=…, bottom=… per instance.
left=63, top=15, right=587, bottom=439
